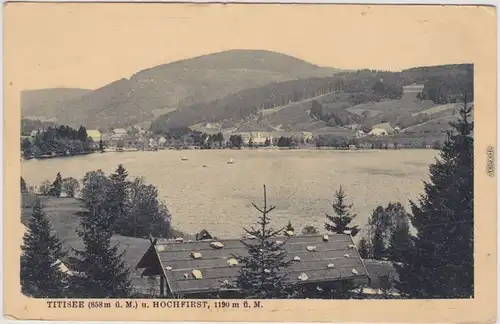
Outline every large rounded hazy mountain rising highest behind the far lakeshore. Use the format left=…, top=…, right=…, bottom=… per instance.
left=22, top=50, right=337, bottom=128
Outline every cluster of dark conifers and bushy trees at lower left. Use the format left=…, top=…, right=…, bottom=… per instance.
left=20, top=165, right=182, bottom=298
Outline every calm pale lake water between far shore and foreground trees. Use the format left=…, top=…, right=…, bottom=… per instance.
left=21, top=150, right=438, bottom=238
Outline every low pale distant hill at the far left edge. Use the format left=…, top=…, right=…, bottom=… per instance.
left=21, top=88, right=91, bottom=120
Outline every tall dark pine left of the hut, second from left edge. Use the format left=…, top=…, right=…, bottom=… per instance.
left=70, top=170, right=130, bottom=298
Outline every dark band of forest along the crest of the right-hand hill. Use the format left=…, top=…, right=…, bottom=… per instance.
left=151, top=65, right=472, bottom=133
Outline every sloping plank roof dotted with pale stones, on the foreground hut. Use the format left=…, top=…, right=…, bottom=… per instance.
left=137, top=234, right=368, bottom=294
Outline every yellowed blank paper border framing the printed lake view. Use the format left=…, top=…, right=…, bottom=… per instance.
left=4, top=3, right=497, bottom=323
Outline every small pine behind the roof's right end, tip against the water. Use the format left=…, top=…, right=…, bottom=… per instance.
left=325, top=186, right=359, bottom=237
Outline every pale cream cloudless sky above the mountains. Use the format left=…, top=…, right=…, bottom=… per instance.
left=4, top=3, right=496, bottom=89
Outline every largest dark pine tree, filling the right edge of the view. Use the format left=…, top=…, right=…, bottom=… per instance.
left=395, top=92, right=474, bottom=298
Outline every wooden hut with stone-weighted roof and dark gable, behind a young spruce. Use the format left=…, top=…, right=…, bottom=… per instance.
left=136, top=234, right=370, bottom=298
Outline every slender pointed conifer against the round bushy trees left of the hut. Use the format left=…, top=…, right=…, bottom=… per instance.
left=109, top=164, right=130, bottom=234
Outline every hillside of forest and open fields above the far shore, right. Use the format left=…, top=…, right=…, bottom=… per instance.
left=151, top=64, right=473, bottom=133
